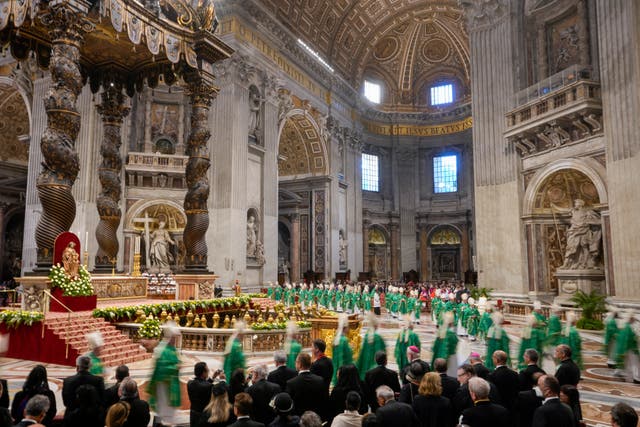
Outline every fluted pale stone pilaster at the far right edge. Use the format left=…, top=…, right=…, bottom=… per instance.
left=596, top=0, right=640, bottom=299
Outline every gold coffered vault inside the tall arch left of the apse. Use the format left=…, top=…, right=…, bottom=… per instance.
left=278, top=109, right=329, bottom=177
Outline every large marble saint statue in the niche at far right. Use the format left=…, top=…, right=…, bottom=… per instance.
left=554, top=199, right=602, bottom=270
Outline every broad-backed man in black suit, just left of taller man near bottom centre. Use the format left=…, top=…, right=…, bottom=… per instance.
left=285, top=353, right=329, bottom=420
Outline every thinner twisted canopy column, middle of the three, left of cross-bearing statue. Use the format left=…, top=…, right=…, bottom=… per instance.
left=95, top=84, right=129, bottom=272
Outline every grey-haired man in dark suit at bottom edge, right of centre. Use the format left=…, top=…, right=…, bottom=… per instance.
left=462, top=377, right=510, bottom=427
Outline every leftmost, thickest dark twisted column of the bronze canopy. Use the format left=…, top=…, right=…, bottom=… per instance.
left=36, top=3, right=93, bottom=270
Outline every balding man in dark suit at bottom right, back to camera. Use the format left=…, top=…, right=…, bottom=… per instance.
left=531, top=375, right=578, bottom=427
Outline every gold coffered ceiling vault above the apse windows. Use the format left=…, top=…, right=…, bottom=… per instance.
left=259, top=0, right=470, bottom=106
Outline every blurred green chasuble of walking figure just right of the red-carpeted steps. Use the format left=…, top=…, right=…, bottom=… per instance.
left=147, top=341, right=180, bottom=410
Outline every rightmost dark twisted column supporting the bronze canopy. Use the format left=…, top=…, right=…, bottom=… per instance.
left=183, top=76, right=218, bottom=272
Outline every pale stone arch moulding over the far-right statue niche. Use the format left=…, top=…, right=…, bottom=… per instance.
left=522, top=159, right=608, bottom=216
